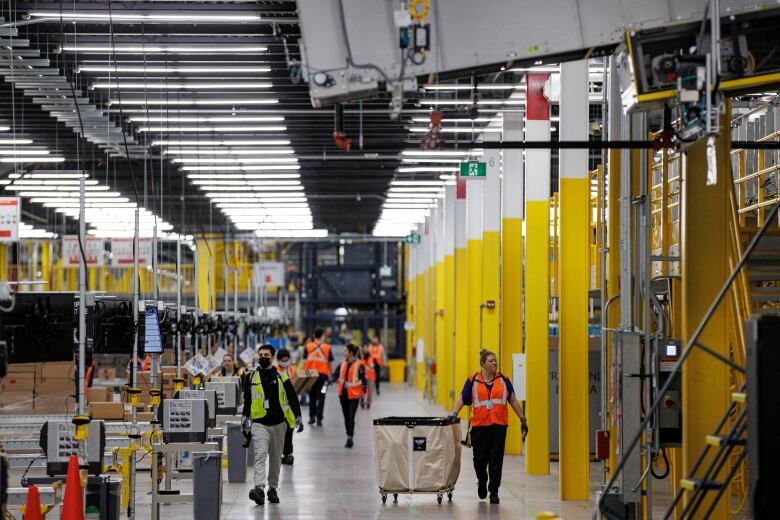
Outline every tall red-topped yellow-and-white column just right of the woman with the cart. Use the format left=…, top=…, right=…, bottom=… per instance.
left=525, top=74, right=550, bottom=475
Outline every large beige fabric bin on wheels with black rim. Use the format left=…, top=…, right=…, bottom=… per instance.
left=374, top=417, right=461, bottom=503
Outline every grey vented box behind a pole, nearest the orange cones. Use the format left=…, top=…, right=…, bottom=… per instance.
left=40, top=420, right=106, bottom=477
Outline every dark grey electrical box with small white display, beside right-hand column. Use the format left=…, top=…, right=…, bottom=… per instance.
left=656, top=339, right=682, bottom=448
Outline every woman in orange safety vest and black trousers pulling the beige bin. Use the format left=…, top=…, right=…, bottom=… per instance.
left=451, top=350, right=528, bottom=504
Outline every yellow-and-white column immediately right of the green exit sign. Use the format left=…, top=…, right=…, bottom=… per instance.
left=482, top=133, right=501, bottom=359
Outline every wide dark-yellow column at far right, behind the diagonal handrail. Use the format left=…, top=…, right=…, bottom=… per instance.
left=674, top=116, right=738, bottom=519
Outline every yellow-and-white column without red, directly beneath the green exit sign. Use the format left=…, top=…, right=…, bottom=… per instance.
left=466, top=180, right=484, bottom=373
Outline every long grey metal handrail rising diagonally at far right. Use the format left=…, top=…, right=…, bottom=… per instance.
left=594, top=201, right=780, bottom=518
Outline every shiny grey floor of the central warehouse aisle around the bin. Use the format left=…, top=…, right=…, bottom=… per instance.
left=138, top=385, right=598, bottom=520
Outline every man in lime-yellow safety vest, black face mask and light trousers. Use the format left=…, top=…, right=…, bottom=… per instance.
left=242, top=344, right=303, bottom=505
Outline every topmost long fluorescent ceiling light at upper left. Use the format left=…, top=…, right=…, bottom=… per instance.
left=35, top=11, right=273, bottom=24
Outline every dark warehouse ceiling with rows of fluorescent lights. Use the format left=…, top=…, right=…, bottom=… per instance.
left=0, top=0, right=522, bottom=235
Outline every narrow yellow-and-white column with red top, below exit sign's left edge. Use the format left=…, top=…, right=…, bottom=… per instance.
left=453, top=180, right=476, bottom=406
